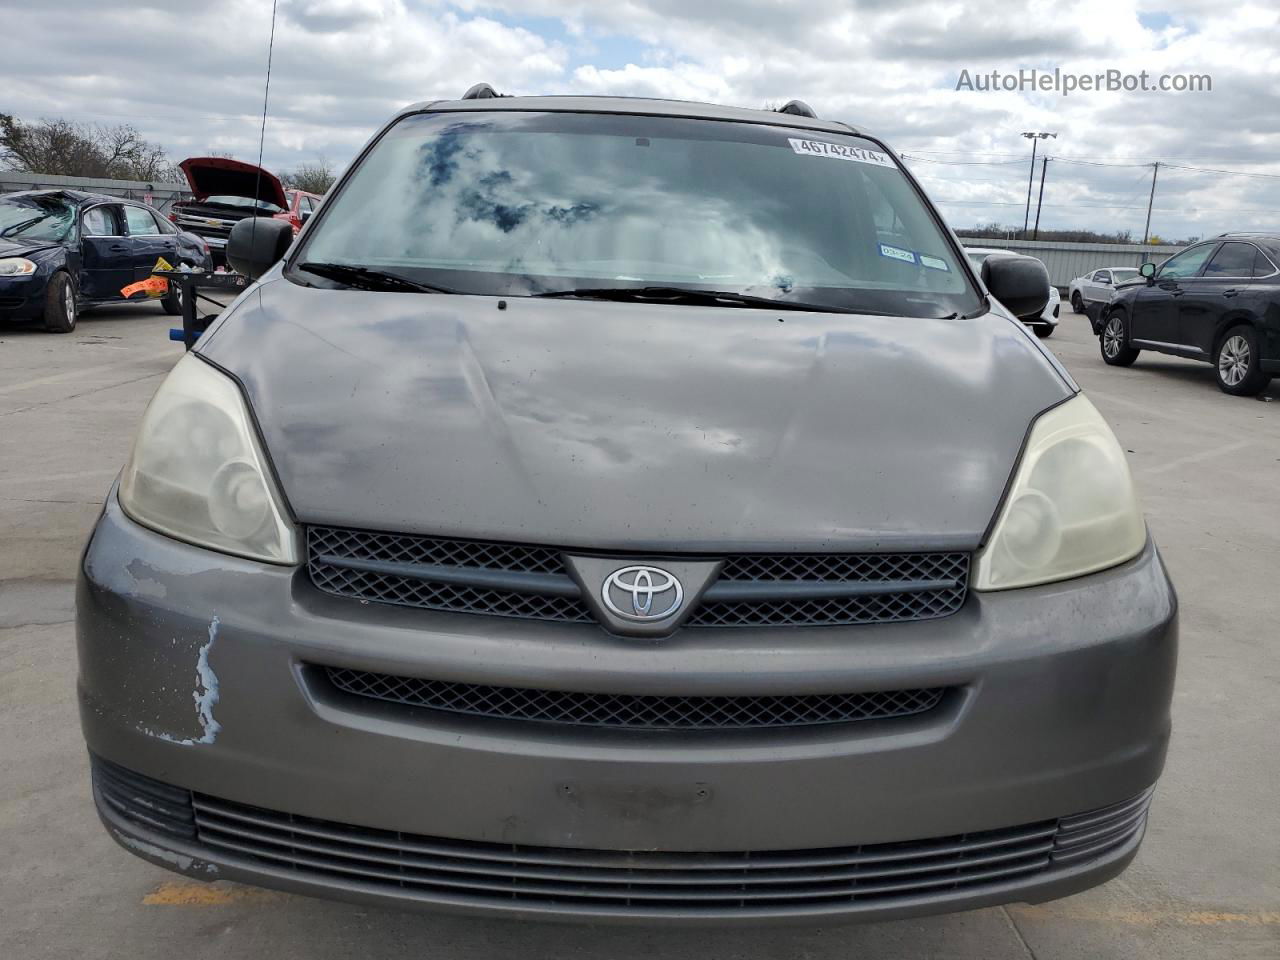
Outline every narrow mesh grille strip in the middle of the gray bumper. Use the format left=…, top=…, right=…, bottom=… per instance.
left=318, top=667, right=946, bottom=730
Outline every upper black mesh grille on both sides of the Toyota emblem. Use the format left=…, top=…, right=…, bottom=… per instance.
left=307, top=526, right=969, bottom=627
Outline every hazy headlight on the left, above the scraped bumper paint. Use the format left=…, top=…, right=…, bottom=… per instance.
left=119, top=353, right=298, bottom=563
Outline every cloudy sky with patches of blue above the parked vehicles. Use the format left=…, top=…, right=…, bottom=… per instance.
left=10, top=0, right=1280, bottom=238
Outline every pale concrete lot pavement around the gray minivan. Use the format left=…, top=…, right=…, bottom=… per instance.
left=0, top=305, right=1280, bottom=960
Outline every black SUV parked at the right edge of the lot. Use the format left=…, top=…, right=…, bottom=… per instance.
left=1100, top=233, right=1280, bottom=397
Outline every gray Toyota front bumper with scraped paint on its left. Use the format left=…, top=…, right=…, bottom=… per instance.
left=77, top=495, right=1176, bottom=920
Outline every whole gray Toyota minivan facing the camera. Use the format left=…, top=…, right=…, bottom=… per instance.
left=77, top=86, right=1176, bottom=923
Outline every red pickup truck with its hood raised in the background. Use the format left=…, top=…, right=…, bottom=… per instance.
left=169, top=156, right=321, bottom=266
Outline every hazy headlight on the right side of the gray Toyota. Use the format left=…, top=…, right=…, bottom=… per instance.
left=974, top=396, right=1147, bottom=590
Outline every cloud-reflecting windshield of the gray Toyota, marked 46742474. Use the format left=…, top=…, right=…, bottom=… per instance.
left=291, top=111, right=982, bottom=316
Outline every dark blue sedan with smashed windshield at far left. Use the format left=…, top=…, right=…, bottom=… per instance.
left=0, top=189, right=212, bottom=333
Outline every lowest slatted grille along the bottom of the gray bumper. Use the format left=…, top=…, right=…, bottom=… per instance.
left=95, top=759, right=1151, bottom=916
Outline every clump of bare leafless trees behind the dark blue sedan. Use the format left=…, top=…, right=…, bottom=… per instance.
left=0, top=114, right=180, bottom=182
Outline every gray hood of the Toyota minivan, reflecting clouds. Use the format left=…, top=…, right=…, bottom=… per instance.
left=200, top=279, right=1073, bottom=552
